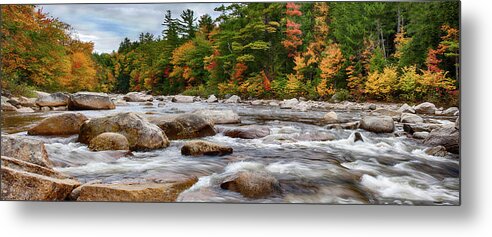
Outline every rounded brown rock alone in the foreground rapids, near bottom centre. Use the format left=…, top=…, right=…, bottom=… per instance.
left=220, top=171, right=281, bottom=198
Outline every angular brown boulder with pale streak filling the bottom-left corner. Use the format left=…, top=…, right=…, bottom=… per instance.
left=1, top=156, right=80, bottom=201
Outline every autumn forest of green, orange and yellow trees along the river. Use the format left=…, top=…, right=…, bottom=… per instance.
left=1, top=1, right=460, bottom=105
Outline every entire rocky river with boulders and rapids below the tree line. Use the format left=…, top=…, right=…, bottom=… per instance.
left=2, top=92, right=460, bottom=205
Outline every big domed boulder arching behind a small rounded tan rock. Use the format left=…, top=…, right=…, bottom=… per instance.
left=78, top=112, right=169, bottom=150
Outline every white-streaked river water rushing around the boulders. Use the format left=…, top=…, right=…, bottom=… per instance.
left=2, top=102, right=460, bottom=205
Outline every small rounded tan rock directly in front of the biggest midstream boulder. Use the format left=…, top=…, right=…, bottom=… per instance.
left=89, top=132, right=130, bottom=151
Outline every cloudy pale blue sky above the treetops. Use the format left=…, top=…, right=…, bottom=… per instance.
left=38, top=3, right=225, bottom=53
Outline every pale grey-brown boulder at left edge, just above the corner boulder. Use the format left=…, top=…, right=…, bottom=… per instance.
left=1, top=135, right=53, bottom=167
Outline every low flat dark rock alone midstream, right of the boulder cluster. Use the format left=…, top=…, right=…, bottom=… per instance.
left=181, top=141, right=232, bottom=156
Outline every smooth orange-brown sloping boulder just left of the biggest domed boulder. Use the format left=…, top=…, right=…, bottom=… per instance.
left=27, top=113, right=88, bottom=135
